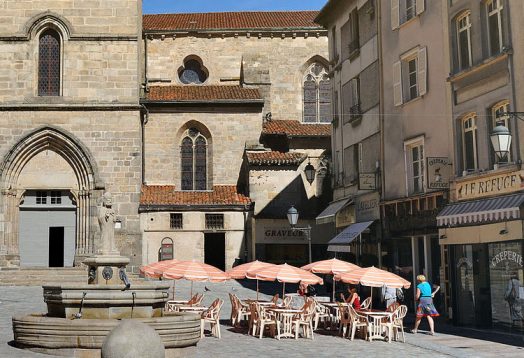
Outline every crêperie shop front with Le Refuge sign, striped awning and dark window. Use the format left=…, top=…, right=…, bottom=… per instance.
left=437, top=169, right=524, bottom=334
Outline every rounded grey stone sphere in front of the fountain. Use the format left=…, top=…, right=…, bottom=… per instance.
left=102, top=319, right=165, bottom=358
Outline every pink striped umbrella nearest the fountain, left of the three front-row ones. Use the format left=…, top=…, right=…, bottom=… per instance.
left=162, top=261, right=230, bottom=296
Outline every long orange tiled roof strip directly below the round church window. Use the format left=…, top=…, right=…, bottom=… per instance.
left=146, top=86, right=263, bottom=101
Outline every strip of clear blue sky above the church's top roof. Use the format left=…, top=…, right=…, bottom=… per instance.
left=139, top=0, right=327, bottom=14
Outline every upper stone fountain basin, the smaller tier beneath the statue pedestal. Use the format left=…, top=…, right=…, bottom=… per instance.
left=43, top=282, right=170, bottom=319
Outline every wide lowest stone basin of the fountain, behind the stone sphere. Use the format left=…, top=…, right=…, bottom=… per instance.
left=12, top=312, right=200, bottom=356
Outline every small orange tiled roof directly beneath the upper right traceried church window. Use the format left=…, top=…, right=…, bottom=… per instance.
left=262, top=119, right=331, bottom=137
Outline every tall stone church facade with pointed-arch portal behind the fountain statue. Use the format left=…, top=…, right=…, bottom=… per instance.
left=0, top=0, right=142, bottom=266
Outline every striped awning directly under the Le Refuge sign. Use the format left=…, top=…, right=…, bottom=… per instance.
left=437, top=193, right=524, bottom=227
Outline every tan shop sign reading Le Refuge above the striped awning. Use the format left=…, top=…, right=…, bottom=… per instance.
left=456, top=170, right=524, bottom=200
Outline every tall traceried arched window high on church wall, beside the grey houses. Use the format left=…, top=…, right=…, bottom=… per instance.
left=303, top=63, right=332, bottom=123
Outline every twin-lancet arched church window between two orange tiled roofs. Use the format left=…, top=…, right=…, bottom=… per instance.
left=180, top=128, right=207, bottom=190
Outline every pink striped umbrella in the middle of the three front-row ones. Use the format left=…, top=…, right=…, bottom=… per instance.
left=246, top=264, right=324, bottom=297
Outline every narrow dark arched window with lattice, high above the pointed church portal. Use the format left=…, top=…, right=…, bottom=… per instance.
left=38, top=29, right=61, bottom=96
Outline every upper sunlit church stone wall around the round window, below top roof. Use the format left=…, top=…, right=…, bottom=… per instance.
left=147, top=33, right=328, bottom=119
